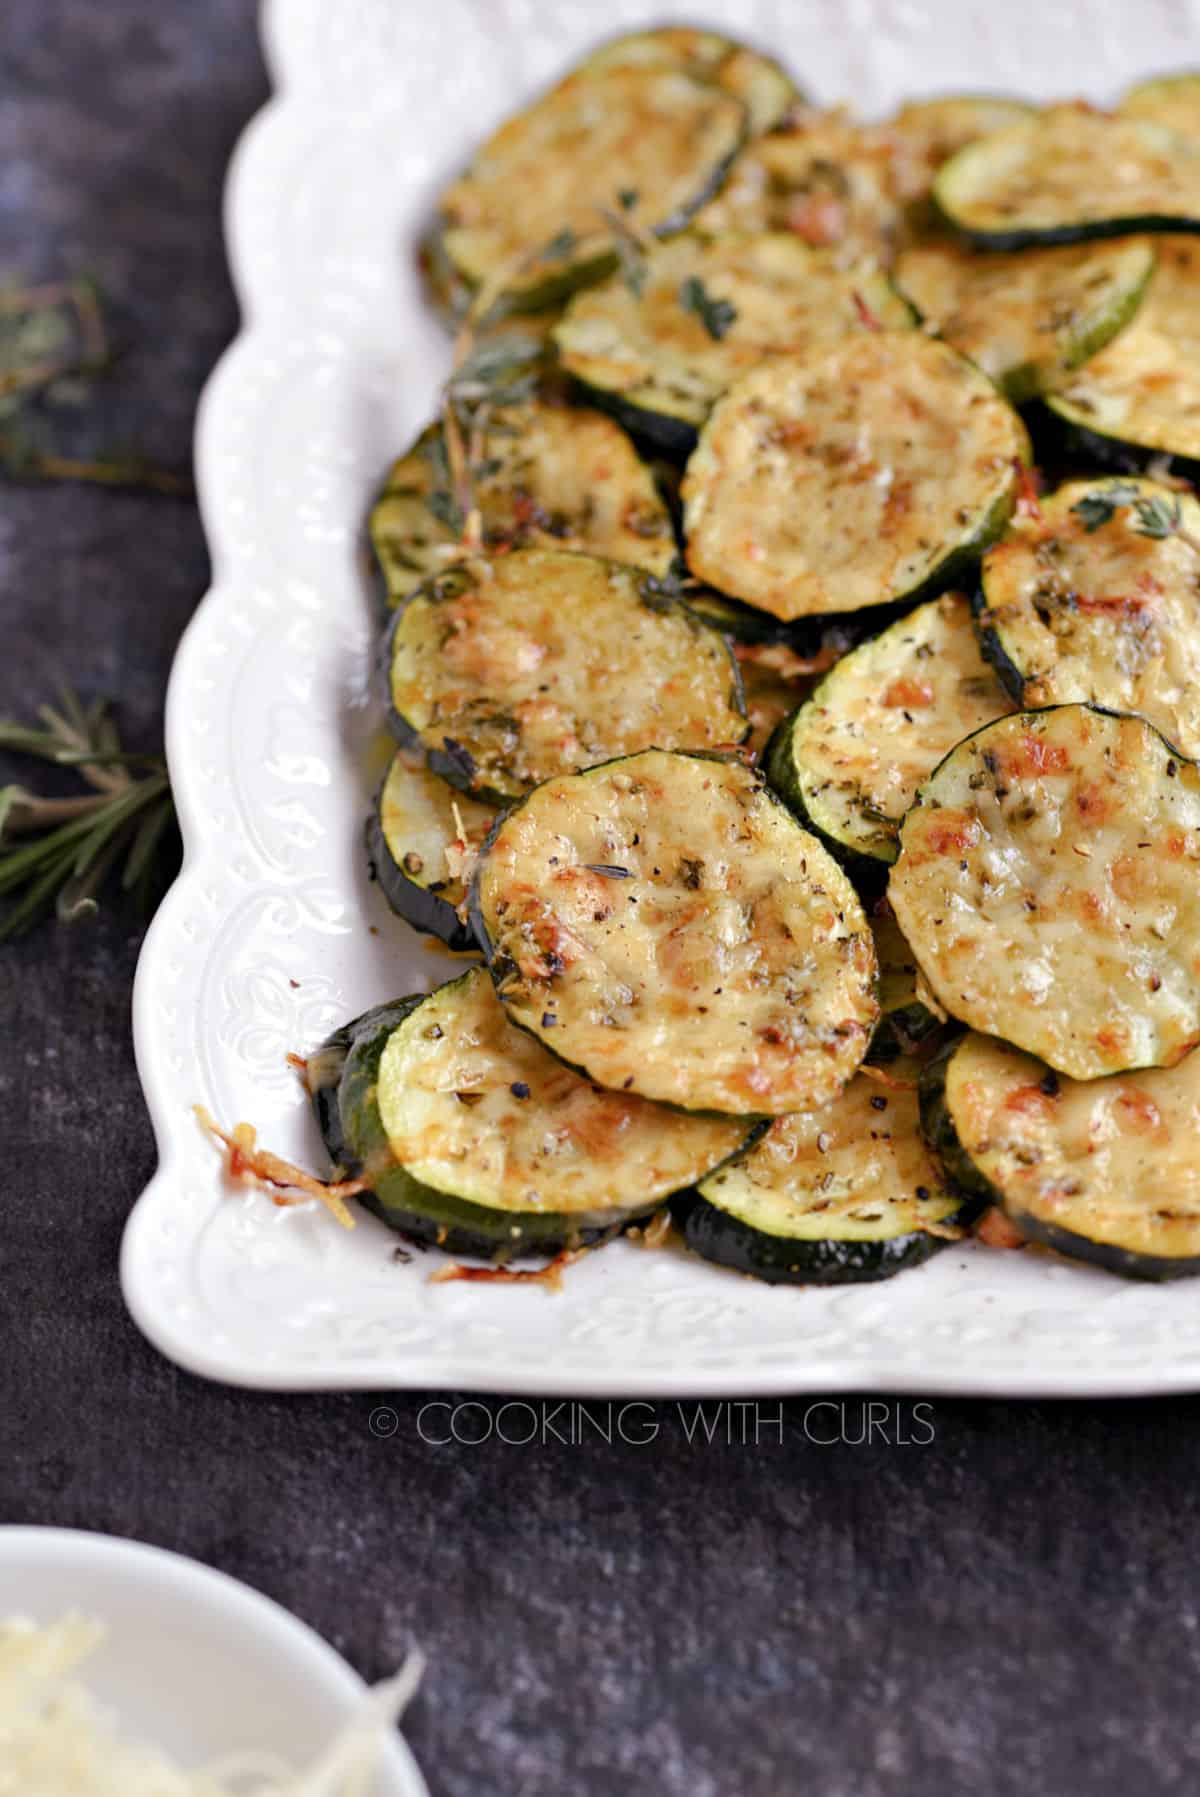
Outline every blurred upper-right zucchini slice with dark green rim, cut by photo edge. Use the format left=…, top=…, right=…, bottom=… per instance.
left=934, top=104, right=1200, bottom=250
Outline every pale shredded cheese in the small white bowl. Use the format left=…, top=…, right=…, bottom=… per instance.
left=0, top=1616, right=424, bottom=1797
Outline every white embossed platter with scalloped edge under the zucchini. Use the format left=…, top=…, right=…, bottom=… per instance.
left=122, top=0, right=1200, bottom=1396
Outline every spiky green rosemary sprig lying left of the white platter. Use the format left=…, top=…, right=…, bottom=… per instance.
left=0, top=690, right=174, bottom=942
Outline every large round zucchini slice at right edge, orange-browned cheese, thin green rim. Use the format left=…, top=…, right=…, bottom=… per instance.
left=887, top=704, right=1200, bottom=1080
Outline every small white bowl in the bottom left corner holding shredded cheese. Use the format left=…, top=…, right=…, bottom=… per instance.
left=0, top=1527, right=428, bottom=1797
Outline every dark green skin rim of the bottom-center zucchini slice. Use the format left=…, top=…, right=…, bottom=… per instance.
left=670, top=1191, right=947, bottom=1285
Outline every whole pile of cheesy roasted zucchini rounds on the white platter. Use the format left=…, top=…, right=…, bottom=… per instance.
left=317, top=27, right=1200, bottom=1283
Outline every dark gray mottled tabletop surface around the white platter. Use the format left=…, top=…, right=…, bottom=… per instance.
left=0, top=0, right=1200, bottom=1797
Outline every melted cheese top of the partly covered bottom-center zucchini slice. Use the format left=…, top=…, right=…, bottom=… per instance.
left=701, top=1066, right=963, bottom=1242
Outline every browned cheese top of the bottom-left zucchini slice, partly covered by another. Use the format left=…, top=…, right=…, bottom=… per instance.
left=377, top=967, right=746, bottom=1217
